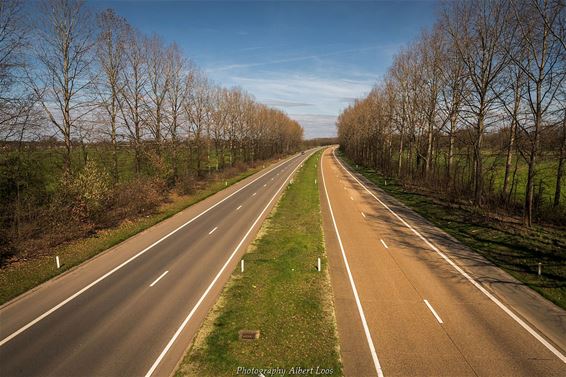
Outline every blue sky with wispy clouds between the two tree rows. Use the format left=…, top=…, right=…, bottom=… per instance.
left=91, top=1, right=437, bottom=138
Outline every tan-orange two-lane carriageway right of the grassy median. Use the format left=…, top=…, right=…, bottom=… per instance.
left=319, top=149, right=566, bottom=376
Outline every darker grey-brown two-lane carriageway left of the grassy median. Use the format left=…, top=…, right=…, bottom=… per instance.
left=0, top=151, right=312, bottom=377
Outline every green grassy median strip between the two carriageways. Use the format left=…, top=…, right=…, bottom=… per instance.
left=175, top=152, right=342, bottom=377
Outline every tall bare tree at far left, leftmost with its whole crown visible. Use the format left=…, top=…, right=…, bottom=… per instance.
left=28, top=0, right=94, bottom=171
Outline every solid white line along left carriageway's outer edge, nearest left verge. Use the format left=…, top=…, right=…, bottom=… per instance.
left=0, top=151, right=300, bottom=347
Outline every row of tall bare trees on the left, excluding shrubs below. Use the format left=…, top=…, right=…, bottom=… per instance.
left=20, top=0, right=302, bottom=176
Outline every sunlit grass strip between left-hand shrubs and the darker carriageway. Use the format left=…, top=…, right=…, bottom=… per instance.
left=0, top=166, right=261, bottom=305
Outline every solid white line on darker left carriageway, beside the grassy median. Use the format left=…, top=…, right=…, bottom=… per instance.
left=145, top=150, right=316, bottom=377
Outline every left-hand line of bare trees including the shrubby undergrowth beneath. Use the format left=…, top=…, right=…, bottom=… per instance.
left=0, top=0, right=303, bottom=259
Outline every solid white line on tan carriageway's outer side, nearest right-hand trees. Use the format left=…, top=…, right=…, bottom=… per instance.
left=332, top=150, right=566, bottom=363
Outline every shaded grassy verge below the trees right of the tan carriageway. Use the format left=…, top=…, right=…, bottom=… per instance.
left=340, top=151, right=566, bottom=309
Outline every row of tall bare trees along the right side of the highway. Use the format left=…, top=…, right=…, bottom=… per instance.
left=337, top=0, right=566, bottom=226
